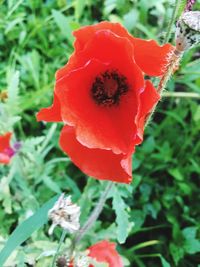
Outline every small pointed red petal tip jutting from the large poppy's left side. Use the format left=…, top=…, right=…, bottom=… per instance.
left=36, top=94, right=62, bottom=122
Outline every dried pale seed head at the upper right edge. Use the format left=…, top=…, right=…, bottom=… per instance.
left=176, top=11, right=200, bottom=53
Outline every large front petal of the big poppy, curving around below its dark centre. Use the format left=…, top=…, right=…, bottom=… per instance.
left=56, top=57, right=141, bottom=153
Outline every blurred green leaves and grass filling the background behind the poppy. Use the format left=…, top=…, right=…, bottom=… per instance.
left=0, top=0, right=200, bottom=267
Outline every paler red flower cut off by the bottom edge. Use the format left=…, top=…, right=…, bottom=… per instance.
left=89, top=240, right=123, bottom=267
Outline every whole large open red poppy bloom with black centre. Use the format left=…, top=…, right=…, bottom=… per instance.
left=37, top=22, right=173, bottom=183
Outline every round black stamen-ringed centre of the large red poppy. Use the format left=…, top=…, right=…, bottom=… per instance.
left=91, top=70, right=129, bottom=107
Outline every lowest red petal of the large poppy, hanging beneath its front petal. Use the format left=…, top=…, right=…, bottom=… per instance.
left=60, top=126, right=132, bottom=183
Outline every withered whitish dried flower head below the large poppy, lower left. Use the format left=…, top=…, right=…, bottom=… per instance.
left=48, top=194, right=80, bottom=235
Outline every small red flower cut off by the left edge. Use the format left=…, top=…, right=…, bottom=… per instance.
left=0, top=132, right=14, bottom=164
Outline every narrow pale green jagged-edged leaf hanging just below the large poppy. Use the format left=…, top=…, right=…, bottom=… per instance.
left=112, top=187, right=129, bottom=244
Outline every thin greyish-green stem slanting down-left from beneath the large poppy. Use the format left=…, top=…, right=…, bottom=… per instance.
left=72, top=182, right=114, bottom=250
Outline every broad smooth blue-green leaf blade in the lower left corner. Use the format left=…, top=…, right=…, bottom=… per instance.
left=0, top=195, right=58, bottom=266
